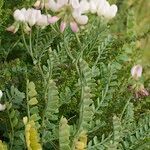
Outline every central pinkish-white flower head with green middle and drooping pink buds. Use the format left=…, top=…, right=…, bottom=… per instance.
left=48, top=0, right=89, bottom=32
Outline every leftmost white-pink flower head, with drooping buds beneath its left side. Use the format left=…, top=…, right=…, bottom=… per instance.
left=7, top=8, right=48, bottom=33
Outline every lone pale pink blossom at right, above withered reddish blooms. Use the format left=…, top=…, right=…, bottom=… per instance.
left=131, top=65, right=143, bottom=79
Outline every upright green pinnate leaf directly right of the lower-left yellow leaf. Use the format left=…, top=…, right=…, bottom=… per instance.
left=42, top=80, right=59, bottom=146
